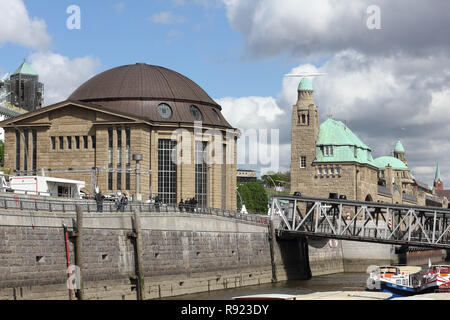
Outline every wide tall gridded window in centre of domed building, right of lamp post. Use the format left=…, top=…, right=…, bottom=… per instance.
left=158, top=139, right=177, bottom=204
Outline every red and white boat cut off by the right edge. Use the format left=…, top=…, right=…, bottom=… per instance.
left=420, top=263, right=450, bottom=293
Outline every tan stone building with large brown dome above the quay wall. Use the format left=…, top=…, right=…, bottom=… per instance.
left=0, top=63, right=239, bottom=210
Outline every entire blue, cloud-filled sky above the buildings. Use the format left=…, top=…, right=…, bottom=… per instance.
left=0, top=0, right=450, bottom=185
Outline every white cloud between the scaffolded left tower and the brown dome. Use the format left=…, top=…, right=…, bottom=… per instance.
left=29, top=52, right=100, bottom=105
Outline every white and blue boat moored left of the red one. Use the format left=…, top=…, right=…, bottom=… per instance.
left=367, top=266, right=423, bottom=297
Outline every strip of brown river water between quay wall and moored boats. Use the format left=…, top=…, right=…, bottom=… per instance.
left=167, top=273, right=369, bottom=300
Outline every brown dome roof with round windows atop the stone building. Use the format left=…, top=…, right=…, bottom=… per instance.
left=69, top=63, right=231, bottom=127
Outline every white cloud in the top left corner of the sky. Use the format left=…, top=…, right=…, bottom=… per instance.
left=0, top=0, right=51, bottom=50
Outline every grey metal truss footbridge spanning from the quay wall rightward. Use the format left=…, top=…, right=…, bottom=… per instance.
left=270, top=196, right=450, bottom=249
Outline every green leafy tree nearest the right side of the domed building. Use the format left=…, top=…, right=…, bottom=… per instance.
left=237, top=182, right=269, bottom=214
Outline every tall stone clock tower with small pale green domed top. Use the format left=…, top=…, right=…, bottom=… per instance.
left=291, top=78, right=320, bottom=193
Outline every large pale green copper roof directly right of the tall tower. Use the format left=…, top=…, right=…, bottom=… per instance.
left=316, top=119, right=376, bottom=167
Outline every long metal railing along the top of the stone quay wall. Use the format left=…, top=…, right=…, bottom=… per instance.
left=0, top=195, right=270, bottom=224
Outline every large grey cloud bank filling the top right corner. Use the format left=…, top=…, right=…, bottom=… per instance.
left=223, top=0, right=450, bottom=57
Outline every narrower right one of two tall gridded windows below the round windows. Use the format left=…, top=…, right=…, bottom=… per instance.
left=195, top=141, right=208, bottom=208
